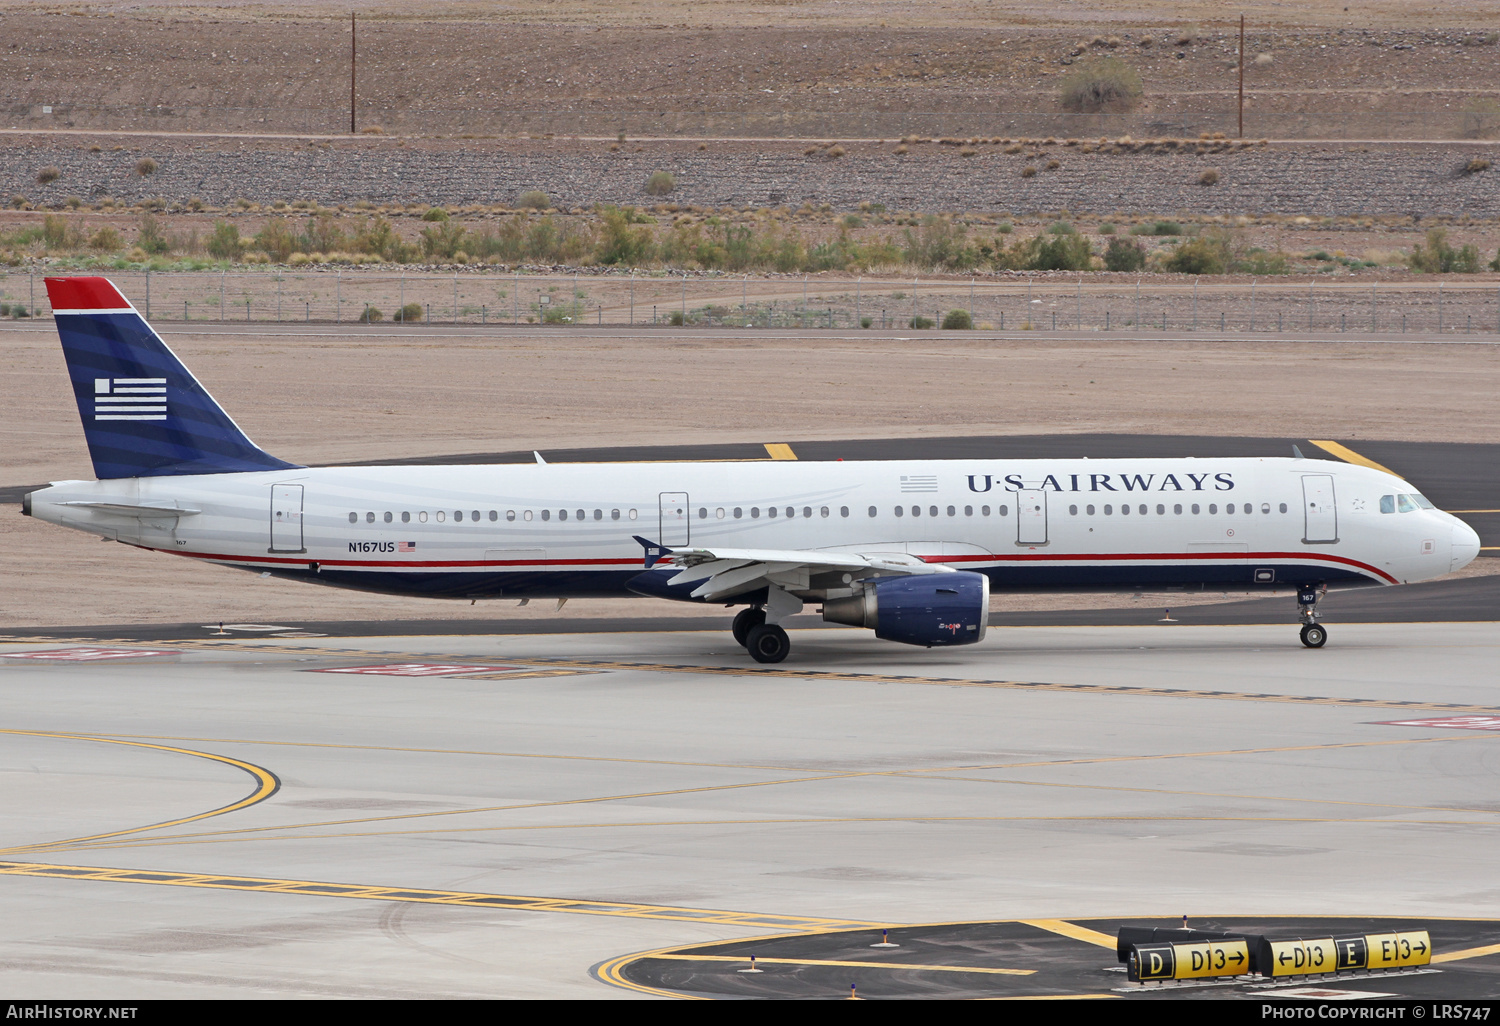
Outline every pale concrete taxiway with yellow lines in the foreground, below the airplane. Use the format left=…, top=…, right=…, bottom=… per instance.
left=0, top=623, right=1500, bottom=999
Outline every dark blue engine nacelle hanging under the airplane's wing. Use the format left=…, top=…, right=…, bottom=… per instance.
left=824, top=572, right=990, bottom=648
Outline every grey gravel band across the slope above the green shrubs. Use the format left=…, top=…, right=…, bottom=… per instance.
left=11, top=140, right=1500, bottom=219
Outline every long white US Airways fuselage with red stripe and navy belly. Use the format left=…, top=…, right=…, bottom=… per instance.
left=29, top=458, right=1479, bottom=599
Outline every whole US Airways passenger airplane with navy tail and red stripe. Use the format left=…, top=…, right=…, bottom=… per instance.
left=23, top=278, right=1479, bottom=663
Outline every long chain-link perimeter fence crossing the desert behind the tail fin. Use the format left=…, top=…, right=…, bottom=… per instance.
left=0, top=269, right=1500, bottom=339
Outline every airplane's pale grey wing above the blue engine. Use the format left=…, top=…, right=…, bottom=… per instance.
left=642, top=542, right=953, bottom=602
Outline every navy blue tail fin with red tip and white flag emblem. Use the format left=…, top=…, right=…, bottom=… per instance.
left=47, top=278, right=297, bottom=480
